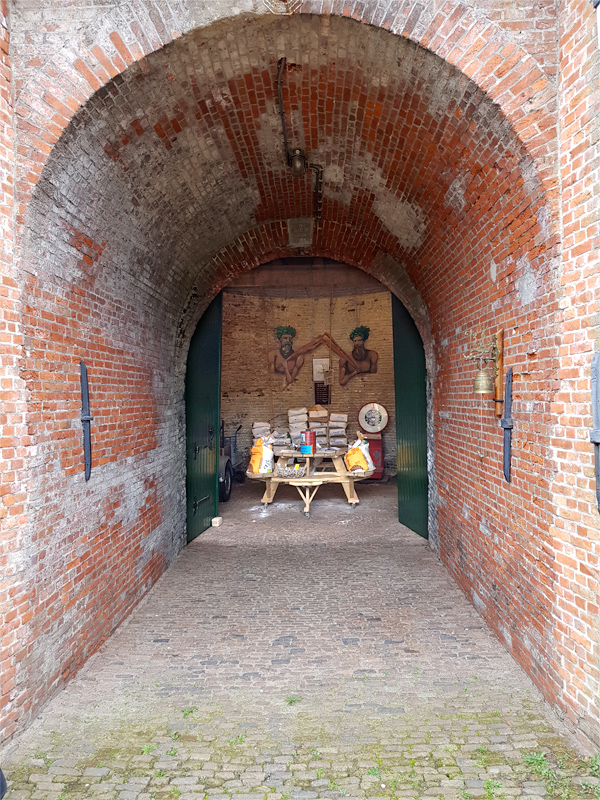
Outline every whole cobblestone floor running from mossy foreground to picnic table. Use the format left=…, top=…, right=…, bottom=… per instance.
left=1, top=482, right=600, bottom=800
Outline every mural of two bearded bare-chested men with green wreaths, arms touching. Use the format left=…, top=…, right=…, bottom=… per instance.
left=269, top=325, right=379, bottom=388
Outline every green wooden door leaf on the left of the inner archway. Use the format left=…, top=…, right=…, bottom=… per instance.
left=185, top=295, right=223, bottom=542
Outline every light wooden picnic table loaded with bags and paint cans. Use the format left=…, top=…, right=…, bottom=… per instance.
left=257, top=449, right=373, bottom=517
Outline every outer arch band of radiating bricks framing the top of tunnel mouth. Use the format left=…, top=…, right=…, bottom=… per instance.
left=15, top=0, right=556, bottom=224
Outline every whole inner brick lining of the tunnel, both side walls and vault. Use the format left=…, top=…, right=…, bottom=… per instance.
left=9, top=15, right=558, bottom=744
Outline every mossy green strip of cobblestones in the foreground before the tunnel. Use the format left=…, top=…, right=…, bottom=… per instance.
left=7, top=709, right=600, bottom=800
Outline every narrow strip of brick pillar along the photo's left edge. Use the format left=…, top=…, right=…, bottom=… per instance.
left=0, top=0, right=29, bottom=741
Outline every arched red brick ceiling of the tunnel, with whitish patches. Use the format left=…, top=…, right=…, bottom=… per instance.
left=25, top=15, right=546, bottom=332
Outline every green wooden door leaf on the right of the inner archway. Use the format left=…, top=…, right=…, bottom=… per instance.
left=392, top=295, right=428, bottom=538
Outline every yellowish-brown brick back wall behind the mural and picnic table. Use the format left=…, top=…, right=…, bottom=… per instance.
left=221, top=267, right=396, bottom=470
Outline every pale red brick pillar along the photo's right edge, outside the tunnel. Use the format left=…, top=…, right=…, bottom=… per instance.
left=553, top=0, right=600, bottom=744
